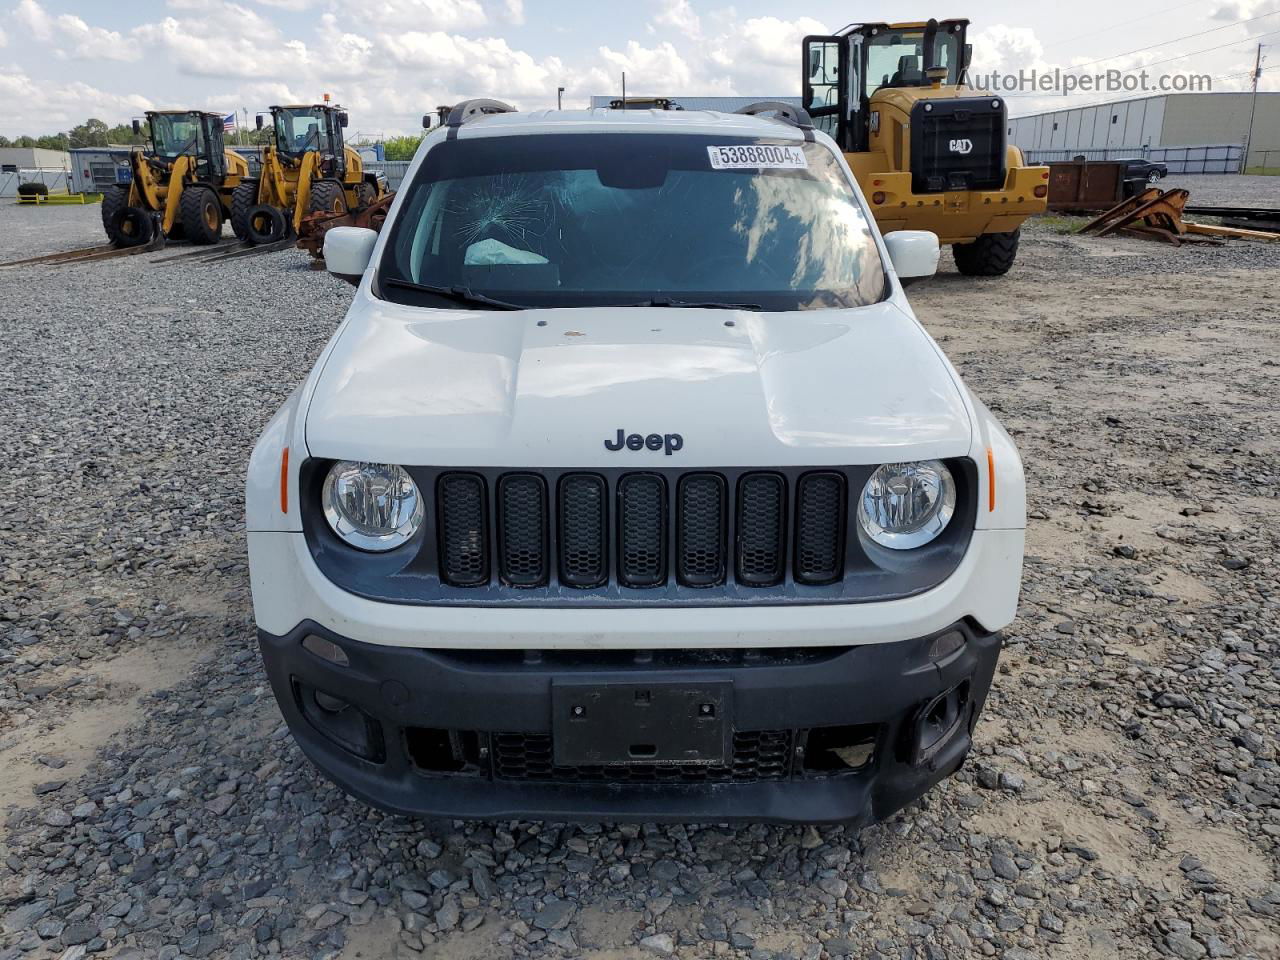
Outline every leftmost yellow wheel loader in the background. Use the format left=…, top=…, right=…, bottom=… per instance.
left=102, top=110, right=248, bottom=247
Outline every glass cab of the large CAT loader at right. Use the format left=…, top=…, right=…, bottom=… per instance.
left=803, top=20, right=969, bottom=154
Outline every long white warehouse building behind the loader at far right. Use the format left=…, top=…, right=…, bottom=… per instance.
left=1009, top=92, right=1280, bottom=173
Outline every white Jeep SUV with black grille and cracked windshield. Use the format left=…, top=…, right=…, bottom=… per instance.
left=247, top=101, right=1025, bottom=822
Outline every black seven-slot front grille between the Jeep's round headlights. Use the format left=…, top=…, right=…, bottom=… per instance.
left=436, top=471, right=847, bottom=590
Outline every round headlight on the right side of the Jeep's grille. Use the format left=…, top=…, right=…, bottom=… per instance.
left=858, top=460, right=956, bottom=550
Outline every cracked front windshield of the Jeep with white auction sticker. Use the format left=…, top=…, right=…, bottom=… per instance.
left=374, top=133, right=888, bottom=312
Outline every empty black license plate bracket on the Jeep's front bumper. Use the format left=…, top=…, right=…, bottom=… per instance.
left=552, top=681, right=732, bottom=767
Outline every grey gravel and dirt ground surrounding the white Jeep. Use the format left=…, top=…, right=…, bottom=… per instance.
left=0, top=205, right=1280, bottom=960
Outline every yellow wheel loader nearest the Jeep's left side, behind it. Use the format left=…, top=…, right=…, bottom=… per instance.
left=232, top=102, right=387, bottom=243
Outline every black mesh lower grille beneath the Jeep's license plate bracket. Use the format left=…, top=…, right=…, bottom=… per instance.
left=492, top=730, right=792, bottom=783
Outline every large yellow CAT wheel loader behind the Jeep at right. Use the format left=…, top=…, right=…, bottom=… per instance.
left=803, top=19, right=1048, bottom=276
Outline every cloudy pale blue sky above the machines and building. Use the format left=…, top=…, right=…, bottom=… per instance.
left=0, top=0, right=1280, bottom=136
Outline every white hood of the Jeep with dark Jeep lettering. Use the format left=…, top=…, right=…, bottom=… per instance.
left=306, top=299, right=972, bottom=467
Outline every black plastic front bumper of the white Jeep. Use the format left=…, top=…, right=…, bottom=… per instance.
left=259, top=622, right=1000, bottom=823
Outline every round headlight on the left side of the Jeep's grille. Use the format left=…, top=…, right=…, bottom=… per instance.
left=320, top=460, right=422, bottom=550
